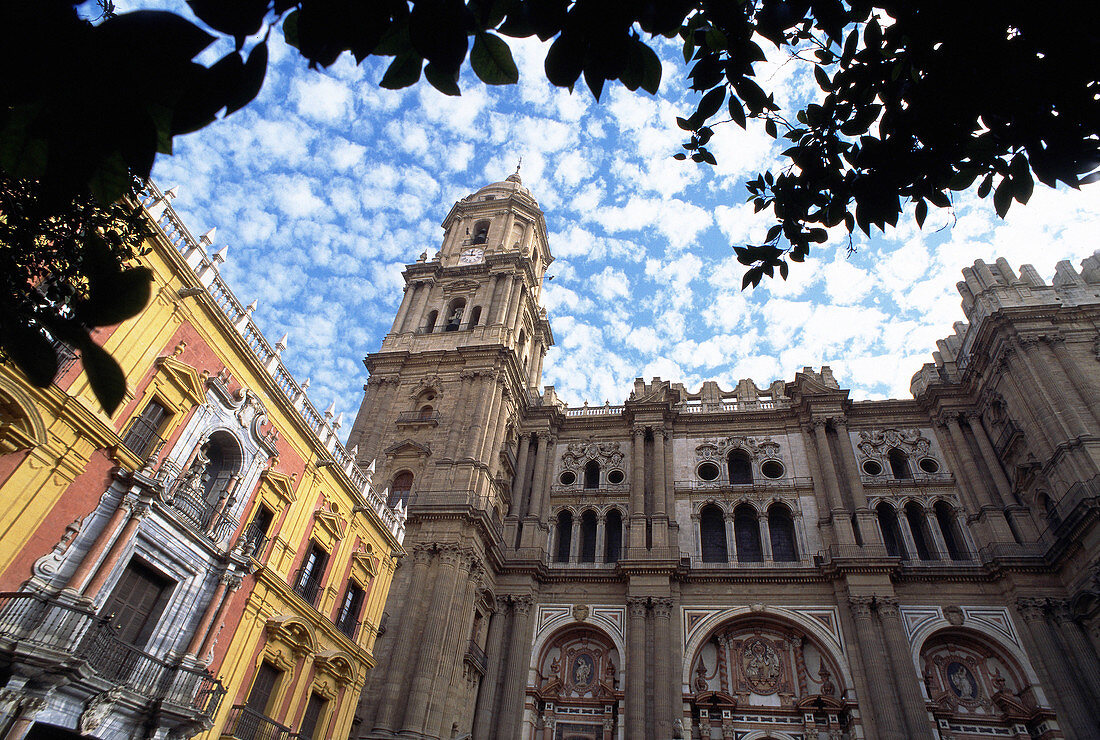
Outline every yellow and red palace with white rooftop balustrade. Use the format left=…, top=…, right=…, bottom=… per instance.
left=0, top=185, right=405, bottom=740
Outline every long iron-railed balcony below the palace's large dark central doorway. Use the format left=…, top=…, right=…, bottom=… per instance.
left=0, top=593, right=226, bottom=722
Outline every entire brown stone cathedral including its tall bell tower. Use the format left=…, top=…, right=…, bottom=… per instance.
left=349, top=174, right=1100, bottom=740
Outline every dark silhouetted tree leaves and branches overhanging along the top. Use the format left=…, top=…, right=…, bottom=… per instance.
left=0, top=0, right=1100, bottom=404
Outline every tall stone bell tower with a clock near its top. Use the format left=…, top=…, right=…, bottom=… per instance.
left=348, top=168, right=553, bottom=738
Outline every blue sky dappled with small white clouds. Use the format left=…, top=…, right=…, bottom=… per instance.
left=135, top=2, right=1100, bottom=437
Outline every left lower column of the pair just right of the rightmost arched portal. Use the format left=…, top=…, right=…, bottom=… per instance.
left=1016, top=598, right=1097, bottom=740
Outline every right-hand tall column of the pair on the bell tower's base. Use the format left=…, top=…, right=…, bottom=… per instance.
left=403, top=545, right=463, bottom=732
